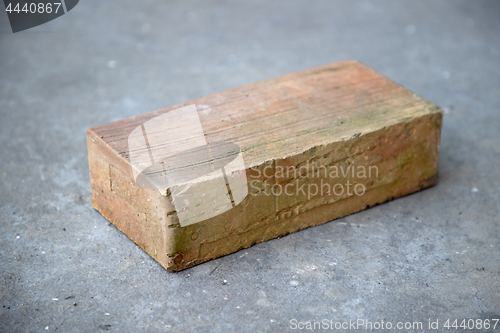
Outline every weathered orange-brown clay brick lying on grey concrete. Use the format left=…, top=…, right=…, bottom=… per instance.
left=87, top=60, right=443, bottom=271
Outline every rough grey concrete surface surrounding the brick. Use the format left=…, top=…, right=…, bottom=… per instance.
left=0, top=0, right=500, bottom=332
